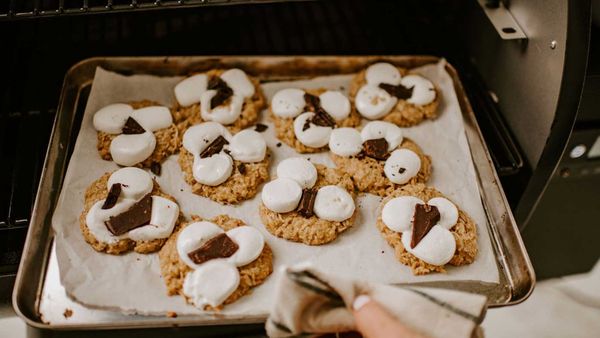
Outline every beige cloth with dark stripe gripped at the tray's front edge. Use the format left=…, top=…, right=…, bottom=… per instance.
left=266, top=267, right=486, bottom=338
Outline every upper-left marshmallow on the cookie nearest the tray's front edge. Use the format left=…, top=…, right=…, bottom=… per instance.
left=177, top=221, right=224, bottom=269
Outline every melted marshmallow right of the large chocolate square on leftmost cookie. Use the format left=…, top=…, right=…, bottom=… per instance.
left=128, top=196, right=179, bottom=241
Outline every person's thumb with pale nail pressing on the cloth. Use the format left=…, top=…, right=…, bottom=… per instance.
left=352, top=295, right=425, bottom=338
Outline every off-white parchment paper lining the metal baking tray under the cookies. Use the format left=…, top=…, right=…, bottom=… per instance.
left=52, top=61, right=499, bottom=316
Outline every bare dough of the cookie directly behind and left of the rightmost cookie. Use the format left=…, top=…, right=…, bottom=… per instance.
left=331, top=138, right=432, bottom=197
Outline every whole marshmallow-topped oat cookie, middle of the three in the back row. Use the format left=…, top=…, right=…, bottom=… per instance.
left=269, top=88, right=361, bottom=153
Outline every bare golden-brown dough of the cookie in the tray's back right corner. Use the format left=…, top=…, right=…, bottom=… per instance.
left=350, top=67, right=442, bottom=127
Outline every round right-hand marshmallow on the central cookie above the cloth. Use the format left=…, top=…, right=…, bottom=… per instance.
left=313, top=185, right=355, bottom=222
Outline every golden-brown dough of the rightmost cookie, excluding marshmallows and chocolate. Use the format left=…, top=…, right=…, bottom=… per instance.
left=376, top=184, right=478, bottom=275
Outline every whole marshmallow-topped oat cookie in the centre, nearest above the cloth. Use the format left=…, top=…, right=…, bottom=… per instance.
left=259, top=158, right=356, bottom=245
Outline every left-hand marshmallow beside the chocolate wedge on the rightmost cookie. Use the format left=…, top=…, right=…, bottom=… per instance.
left=381, top=196, right=425, bottom=232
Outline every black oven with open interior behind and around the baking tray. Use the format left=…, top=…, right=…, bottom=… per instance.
left=0, top=0, right=600, bottom=332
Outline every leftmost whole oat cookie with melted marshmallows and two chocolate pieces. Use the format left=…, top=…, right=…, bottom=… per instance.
left=79, top=167, right=182, bottom=255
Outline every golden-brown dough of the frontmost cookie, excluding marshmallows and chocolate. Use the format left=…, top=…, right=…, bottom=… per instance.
left=158, top=215, right=273, bottom=311
